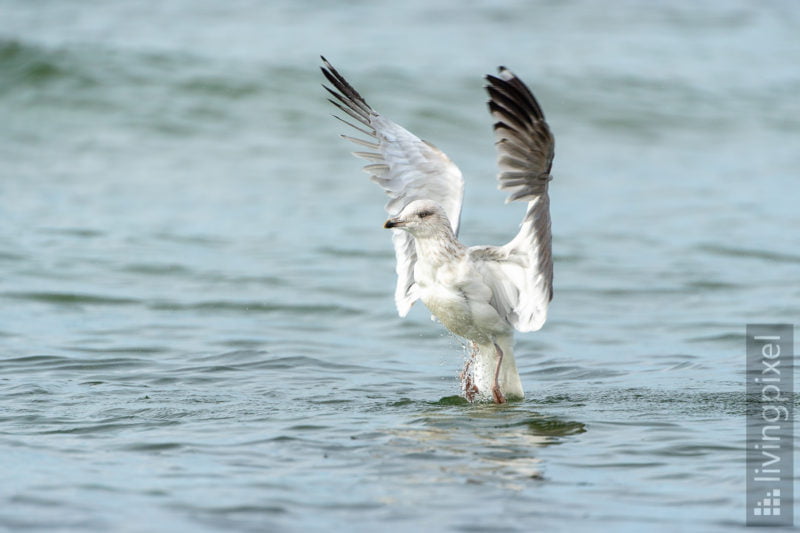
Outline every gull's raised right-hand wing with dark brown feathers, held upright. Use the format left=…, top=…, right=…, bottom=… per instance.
left=470, top=67, right=555, bottom=331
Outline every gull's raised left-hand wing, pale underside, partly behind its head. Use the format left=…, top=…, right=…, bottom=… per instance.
left=321, top=57, right=464, bottom=316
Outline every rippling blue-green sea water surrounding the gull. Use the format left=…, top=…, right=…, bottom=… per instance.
left=0, top=0, right=800, bottom=532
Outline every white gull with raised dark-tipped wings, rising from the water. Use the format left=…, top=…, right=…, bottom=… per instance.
left=320, top=57, right=554, bottom=403
